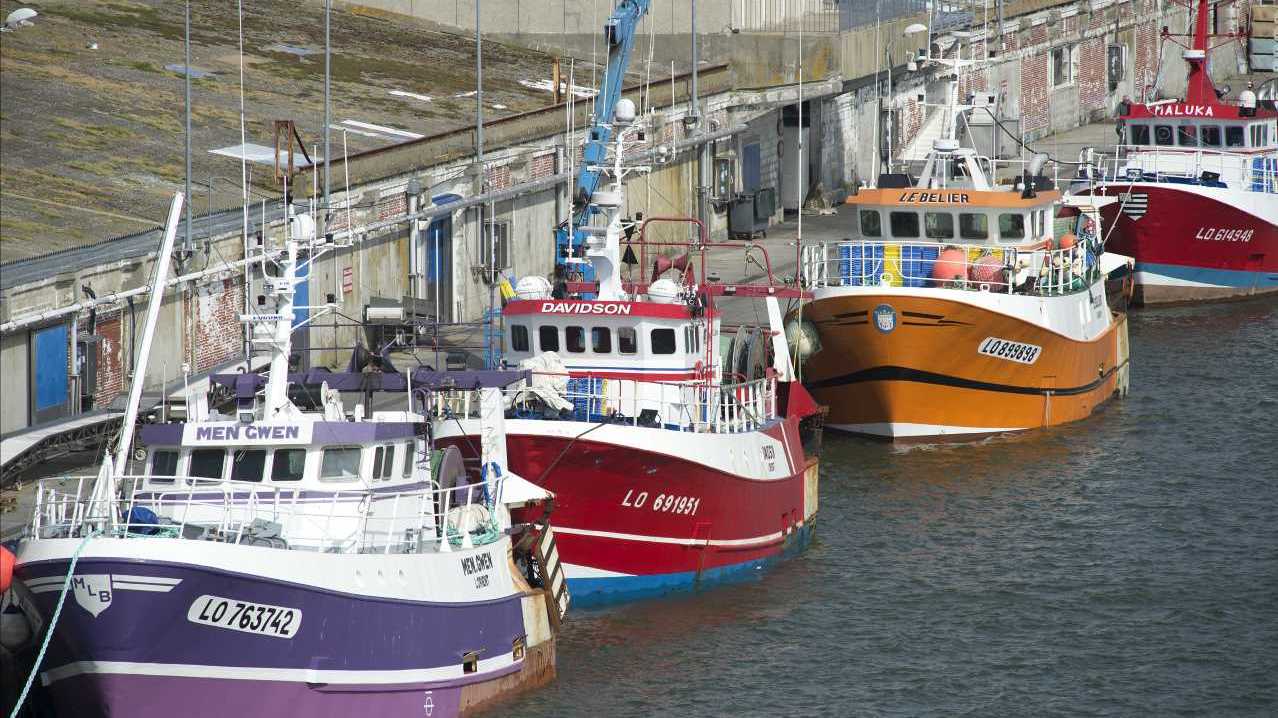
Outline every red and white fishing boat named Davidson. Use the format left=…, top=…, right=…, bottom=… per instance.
left=436, top=100, right=822, bottom=603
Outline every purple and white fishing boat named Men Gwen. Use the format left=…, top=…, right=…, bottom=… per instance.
left=4, top=194, right=567, bottom=718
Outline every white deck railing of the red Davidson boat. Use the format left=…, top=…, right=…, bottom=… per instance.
left=431, top=372, right=777, bottom=433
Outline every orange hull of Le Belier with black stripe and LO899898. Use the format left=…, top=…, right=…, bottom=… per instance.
left=803, top=293, right=1127, bottom=438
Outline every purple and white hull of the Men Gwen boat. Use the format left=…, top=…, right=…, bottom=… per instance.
left=18, top=539, right=555, bottom=717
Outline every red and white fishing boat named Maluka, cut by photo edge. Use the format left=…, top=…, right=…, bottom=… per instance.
left=1074, top=0, right=1278, bottom=304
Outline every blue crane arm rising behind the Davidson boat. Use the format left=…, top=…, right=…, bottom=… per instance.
left=555, top=0, right=651, bottom=281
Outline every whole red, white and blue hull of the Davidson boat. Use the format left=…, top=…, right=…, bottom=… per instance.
left=436, top=419, right=819, bottom=606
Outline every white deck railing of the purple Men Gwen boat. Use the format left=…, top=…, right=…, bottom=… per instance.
left=28, top=475, right=509, bottom=553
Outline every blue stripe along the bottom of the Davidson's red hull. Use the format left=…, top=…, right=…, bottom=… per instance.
left=567, top=520, right=814, bottom=608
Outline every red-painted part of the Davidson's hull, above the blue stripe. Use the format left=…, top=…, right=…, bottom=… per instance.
left=438, top=419, right=815, bottom=576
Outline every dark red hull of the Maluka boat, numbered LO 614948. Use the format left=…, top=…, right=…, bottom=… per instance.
left=1083, top=183, right=1278, bottom=304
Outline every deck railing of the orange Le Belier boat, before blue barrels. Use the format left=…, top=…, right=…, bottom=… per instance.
left=801, top=240, right=1100, bottom=296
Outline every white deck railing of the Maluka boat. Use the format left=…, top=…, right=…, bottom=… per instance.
left=1080, top=144, right=1278, bottom=193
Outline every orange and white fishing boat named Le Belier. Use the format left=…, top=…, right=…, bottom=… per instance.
left=791, top=55, right=1128, bottom=441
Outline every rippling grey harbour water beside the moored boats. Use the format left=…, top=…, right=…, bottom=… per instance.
left=500, top=295, right=1278, bottom=717
